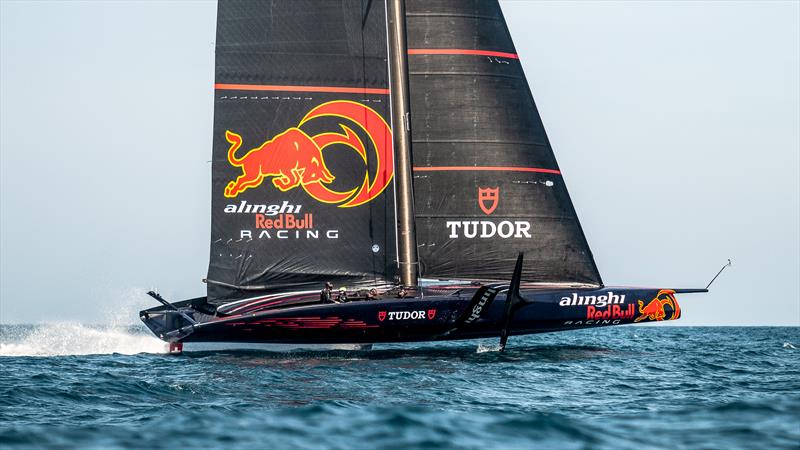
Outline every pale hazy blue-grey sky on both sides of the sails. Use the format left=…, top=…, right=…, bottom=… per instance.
left=0, top=0, right=800, bottom=325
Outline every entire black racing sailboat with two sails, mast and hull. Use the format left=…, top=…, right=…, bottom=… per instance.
left=140, top=0, right=706, bottom=351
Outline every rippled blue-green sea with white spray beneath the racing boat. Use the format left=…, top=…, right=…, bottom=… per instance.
left=0, top=324, right=800, bottom=449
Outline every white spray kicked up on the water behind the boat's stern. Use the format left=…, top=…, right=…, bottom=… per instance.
left=0, top=323, right=167, bottom=356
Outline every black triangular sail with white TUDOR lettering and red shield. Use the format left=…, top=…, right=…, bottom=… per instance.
left=406, top=0, right=602, bottom=285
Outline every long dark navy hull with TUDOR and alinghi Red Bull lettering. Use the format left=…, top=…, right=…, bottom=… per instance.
left=141, top=287, right=692, bottom=344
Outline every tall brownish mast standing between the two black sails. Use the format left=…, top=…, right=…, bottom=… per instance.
left=386, top=0, right=419, bottom=286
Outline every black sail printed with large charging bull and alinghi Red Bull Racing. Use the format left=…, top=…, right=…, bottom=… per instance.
left=208, top=0, right=396, bottom=303
